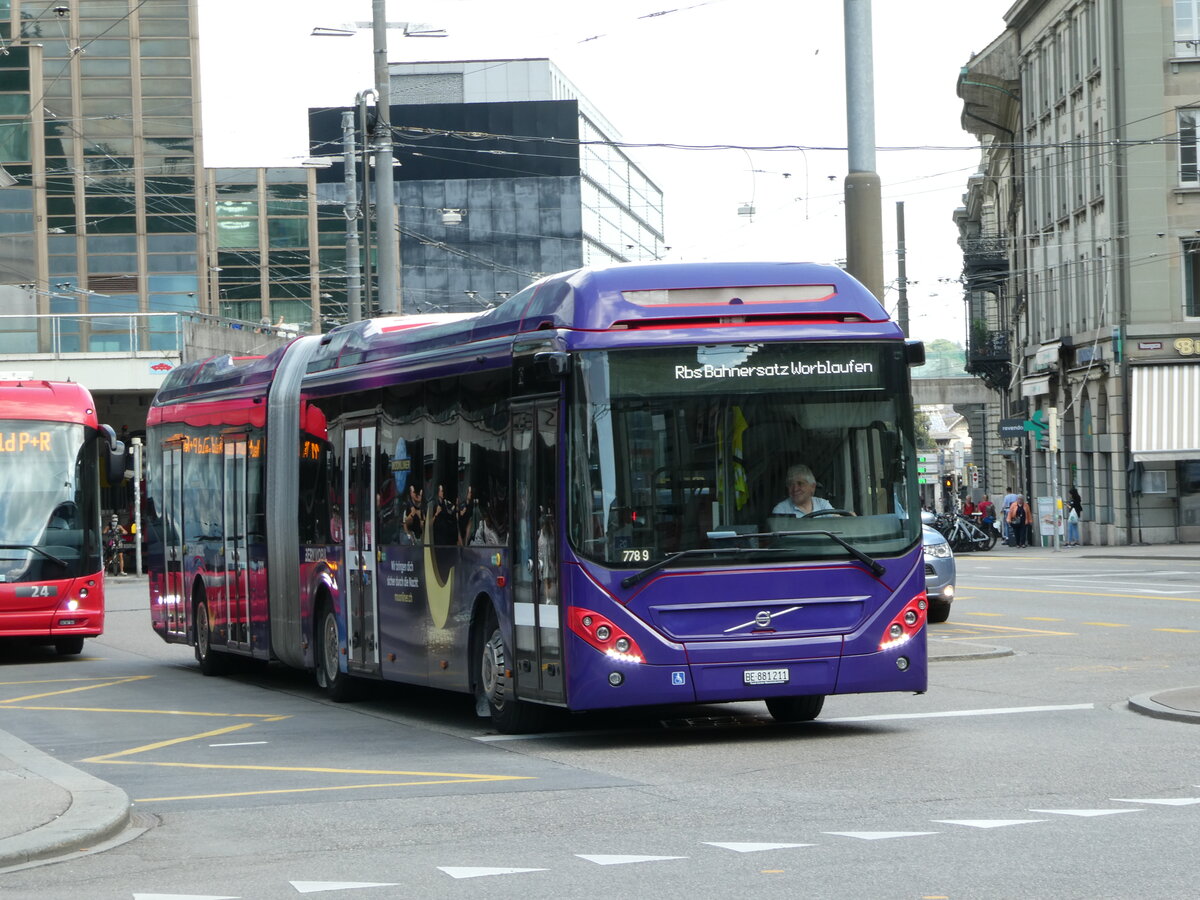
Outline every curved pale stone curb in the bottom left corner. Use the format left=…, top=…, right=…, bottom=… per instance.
left=0, top=731, right=132, bottom=869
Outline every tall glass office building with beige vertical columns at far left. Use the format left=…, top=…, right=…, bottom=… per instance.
left=0, top=0, right=206, bottom=353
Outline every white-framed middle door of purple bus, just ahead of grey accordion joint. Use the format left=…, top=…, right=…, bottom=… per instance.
left=342, top=424, right=379, bottom=671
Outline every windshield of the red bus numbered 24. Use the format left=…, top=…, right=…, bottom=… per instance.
left=0, top=420, right=100, bottom=582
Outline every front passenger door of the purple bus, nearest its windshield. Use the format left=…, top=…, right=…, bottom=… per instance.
left=512, top=398, right=566, bottom=703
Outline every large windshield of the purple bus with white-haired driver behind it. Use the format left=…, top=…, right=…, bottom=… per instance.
left=568, top=341, right=920, bottom=568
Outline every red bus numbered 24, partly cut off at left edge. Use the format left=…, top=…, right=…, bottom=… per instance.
left=0, top=379, right=125, bottom=655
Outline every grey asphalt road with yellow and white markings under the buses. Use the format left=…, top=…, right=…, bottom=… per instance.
left=0, top=547, right=1200, bottom=900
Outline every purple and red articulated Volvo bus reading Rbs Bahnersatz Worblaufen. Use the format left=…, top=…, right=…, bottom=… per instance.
left=148, top=263, right=926, bottom=732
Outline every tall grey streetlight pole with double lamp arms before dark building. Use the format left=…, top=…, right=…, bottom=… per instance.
left=371, top=0, right=403, bottom=316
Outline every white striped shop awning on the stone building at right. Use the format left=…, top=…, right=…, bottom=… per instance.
left=1129, top=364, right=1200, bottom=462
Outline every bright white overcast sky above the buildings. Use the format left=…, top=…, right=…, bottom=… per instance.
left=199, top=0, right=1014, bottom=343
